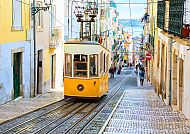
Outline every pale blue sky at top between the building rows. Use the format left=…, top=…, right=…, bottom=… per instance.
left=115, top=0, right=147, bottom=19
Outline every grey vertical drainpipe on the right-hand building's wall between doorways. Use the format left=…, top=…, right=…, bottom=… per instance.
left=168, top=35, right=174, bottom=106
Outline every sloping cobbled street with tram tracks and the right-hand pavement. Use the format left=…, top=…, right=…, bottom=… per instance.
left=0, top=68, right=190, bottom=134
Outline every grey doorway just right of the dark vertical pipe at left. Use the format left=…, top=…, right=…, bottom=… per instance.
left=37, top=50, right=43, bottom=94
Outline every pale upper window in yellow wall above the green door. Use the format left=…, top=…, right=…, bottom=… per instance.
left=12, top=0, right=22, bottom=30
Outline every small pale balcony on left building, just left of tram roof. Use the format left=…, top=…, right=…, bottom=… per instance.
left=49, top=27, right=62, bottom=48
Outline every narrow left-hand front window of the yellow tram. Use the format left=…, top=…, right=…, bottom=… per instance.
left=65, top=54, right=72, bottom=77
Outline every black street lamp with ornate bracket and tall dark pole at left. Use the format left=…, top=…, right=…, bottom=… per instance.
left=31, top=0, right=53, bottom=97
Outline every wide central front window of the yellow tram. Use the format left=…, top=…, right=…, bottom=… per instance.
left=74, top=54, right=88, bottom=77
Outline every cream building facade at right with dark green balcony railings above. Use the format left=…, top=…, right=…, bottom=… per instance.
left=150, top=0, right=190, bottom=118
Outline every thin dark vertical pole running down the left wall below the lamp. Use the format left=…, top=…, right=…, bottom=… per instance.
left=32, top=0, right=36, bottom=97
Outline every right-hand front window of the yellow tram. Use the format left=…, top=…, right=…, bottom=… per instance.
left=89, top=54, right=98, bottom=77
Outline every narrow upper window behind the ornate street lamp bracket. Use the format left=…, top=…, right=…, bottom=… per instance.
left=36, top=1, right=43, bottom=28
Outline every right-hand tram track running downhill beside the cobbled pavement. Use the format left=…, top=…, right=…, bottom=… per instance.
left=35, top=76, right=126, bottom=134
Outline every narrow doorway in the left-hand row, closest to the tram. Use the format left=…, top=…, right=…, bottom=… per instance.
left=51, top=54, right=56, bottom=89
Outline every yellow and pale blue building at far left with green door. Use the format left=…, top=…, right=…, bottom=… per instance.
left=0, top=0, right=31, bottom=104
